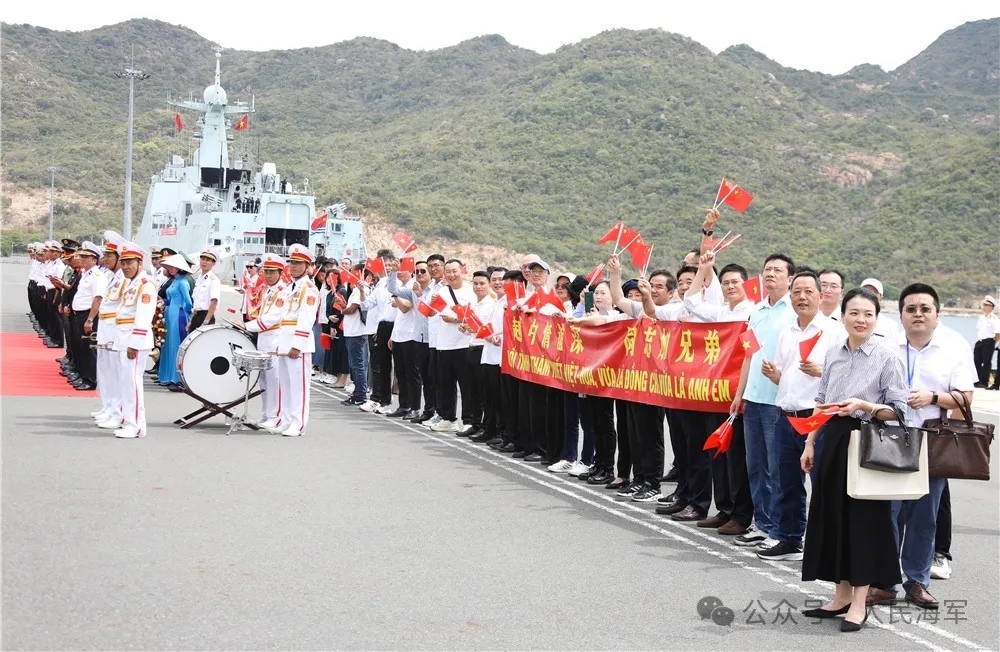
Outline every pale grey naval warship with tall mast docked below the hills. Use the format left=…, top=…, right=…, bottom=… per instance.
left=137, top=50, right=365, bottom=280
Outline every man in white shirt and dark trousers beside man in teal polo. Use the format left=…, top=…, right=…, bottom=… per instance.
left=757, top=271, right=847, bottom=561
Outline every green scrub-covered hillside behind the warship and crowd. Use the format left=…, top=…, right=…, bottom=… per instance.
left=0, top=19, right=1000, bottom=297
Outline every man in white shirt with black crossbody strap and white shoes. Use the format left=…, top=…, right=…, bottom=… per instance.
left=431, top=258, right=476, bottom=433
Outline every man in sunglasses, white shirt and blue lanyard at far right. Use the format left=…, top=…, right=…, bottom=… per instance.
left=868, top=283, right=976, bottom=609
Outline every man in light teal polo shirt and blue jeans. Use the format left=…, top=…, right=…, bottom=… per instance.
left=729, top=254, right=795, bottom=548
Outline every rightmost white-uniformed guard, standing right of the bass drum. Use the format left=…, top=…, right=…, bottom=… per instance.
left=269, top=244, right=319, bottom=437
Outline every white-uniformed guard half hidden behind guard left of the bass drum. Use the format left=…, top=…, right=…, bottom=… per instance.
left=91, top=231, right=126, bottom=430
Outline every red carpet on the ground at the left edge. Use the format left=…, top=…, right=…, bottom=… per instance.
left=0, top=333, right=97, bottom=398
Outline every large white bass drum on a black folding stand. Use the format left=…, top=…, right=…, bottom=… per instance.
left=177, top=324, right=260, bottom=404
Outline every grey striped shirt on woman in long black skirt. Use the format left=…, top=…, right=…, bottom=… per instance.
left=816, top=336, right=910, bottom=419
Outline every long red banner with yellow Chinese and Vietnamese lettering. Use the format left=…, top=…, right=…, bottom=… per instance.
left=502, top=310, right=746, bottom=412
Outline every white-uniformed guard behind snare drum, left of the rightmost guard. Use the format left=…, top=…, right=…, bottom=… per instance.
left=243, top=254, right=288, bottom=430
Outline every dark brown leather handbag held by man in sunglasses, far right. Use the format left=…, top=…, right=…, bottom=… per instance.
left=924, top=392, right=995, bottom=480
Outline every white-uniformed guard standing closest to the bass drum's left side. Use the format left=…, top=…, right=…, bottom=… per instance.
left=115, top=242, right=156, bottom=439
